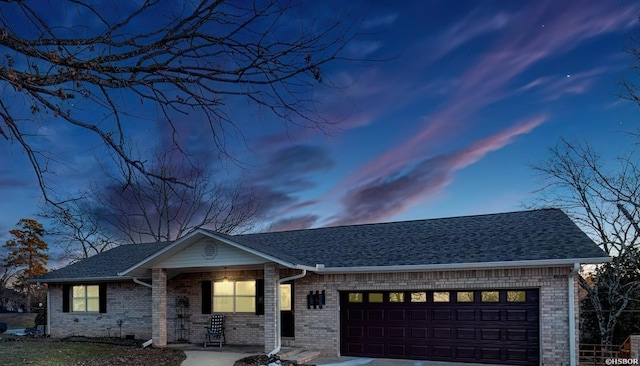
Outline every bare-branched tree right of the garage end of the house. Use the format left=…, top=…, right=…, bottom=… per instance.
left=534, top=139, right=640, bottom=345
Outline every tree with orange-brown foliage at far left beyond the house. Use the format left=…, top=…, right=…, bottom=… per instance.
left=4, top=219, right=49, bottom=311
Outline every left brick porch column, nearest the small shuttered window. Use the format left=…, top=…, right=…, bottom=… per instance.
left=151, top=268, right=167, bottom=347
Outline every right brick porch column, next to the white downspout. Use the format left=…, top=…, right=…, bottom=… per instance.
left=264, top=263, right=280, bottom=353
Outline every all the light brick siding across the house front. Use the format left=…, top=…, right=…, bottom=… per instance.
left=50, top=265, right=578, bottom=365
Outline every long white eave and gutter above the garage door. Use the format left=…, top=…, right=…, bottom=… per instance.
left=313, top=257, right=611, bottom=274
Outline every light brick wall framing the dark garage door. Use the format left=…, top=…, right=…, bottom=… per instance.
left=295, top=268, right=577, bottom=365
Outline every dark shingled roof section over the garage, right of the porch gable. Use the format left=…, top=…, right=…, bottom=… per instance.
left=234, top=209, right=608, bottom=267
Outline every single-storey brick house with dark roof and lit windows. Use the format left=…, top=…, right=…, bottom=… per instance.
left=33, top=209, right=610, bottom=365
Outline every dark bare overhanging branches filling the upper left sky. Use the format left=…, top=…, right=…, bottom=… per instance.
left=0, top=0, right=357, bottom=201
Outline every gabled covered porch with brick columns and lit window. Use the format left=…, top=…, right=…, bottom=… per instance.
left=122, top=232, right=306, bottom=353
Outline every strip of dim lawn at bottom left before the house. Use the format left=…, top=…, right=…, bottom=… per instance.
left=0, top=334, right=185, bottom=366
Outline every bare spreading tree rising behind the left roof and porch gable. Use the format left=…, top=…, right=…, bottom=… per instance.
left=43, top=146, right=258, bottom=246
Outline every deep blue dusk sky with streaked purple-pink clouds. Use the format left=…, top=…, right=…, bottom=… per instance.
left=0, top=0, right=640, bottom=256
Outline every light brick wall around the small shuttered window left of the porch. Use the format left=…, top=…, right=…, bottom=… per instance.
left=49, top=282, right=151, bottom=340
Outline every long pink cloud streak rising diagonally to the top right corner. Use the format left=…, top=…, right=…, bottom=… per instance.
left=336, top=2, right=633, bottom=191
